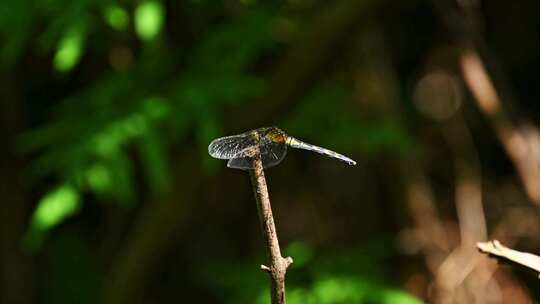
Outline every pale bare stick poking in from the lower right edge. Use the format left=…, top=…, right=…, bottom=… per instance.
left=476, top=240, right=540, bottom=273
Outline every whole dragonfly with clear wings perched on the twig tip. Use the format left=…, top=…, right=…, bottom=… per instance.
left=208, top=127, right=356, bottom=170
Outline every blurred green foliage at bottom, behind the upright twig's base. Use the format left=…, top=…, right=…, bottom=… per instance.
left=205, top=242, right=422, bottom=304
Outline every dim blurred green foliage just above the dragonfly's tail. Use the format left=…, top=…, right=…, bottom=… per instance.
left=283, top=83, right=413, bottom=155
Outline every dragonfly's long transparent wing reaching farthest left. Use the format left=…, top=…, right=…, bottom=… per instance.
left=208, top=133, right=257, bottom=159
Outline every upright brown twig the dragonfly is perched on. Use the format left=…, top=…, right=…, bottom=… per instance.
left=249, top=156, right=293, bottom=304
